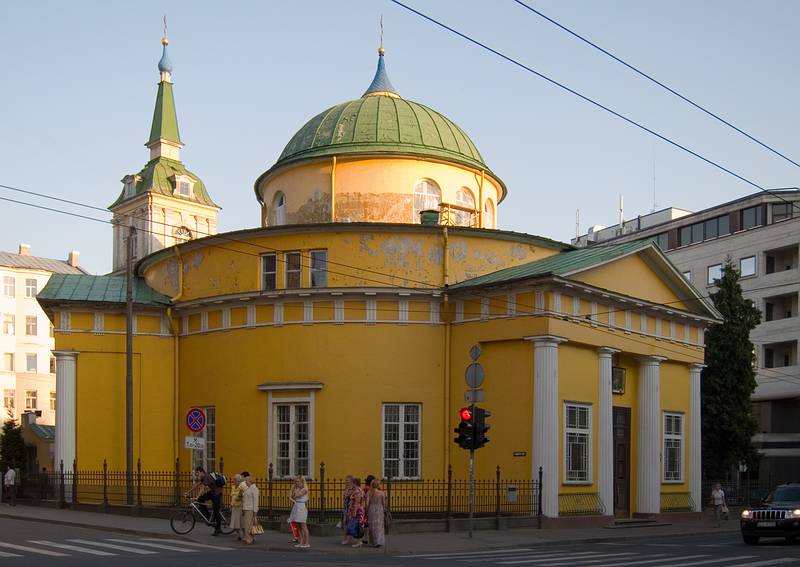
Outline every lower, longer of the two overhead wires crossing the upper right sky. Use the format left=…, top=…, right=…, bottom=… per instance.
left=389, top=0, right=800, bottom=215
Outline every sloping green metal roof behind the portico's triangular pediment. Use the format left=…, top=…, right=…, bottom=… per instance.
left=448, top=240, right=654, bottom=290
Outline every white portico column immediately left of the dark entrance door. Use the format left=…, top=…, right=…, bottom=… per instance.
left=597, top=347, right=619, bottom=515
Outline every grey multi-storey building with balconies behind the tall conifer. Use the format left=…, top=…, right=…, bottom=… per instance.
left=573, top=188, right=800, bottom=482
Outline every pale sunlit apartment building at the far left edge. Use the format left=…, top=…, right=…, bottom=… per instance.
left=0, top=244, right=86, bottom=425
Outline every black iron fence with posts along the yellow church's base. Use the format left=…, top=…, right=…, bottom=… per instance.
left=19, top=459, right=542, bottom=523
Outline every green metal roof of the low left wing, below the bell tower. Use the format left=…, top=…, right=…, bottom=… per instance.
left=36, top=274, right=171, bottom=307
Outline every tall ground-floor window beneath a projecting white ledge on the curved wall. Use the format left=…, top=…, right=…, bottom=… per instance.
left=272, top=403, right=311, bottom=478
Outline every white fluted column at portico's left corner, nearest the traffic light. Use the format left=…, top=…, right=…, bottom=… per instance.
left=525, top=336, right=566, bottom=518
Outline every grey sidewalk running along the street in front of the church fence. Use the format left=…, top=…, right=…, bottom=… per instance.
left=0, top=505, right=739, bottom=554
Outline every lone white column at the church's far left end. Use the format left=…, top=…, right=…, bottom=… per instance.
left=53, top=350, right=78, bottom=471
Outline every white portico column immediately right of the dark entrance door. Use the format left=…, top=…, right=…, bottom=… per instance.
left=636, top=356, right=666, bottom=514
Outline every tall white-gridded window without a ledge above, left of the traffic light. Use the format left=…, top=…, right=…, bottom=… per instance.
left=382, top=404, right=422, bottom=479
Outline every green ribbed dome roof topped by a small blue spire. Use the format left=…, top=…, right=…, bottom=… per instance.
left=256, top=51, right=505, bottom=199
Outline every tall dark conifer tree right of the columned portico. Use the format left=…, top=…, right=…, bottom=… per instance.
left=702, top=258, right=761, bottom=479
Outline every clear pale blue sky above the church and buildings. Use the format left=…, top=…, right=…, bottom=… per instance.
left=0, top=0, right=800, bottom=273
